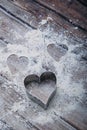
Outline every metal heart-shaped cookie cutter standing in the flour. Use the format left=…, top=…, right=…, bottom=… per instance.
left=24, top=72, right=57, bottom=109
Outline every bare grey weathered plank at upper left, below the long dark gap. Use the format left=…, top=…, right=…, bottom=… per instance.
left=0, top=9, right=31, bottom=44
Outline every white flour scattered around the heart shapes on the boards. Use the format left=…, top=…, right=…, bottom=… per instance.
left=0, top=21, right=85, bottom=123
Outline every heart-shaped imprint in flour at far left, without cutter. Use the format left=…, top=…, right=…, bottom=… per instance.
left=7, top=54, right=28, bottom=74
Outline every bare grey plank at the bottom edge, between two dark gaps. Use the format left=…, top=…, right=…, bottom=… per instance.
left=14, top=110, right=77, bottom=130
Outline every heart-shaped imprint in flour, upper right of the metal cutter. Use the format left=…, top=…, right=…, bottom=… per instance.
left=47, top=44, right=68, bottom=61
